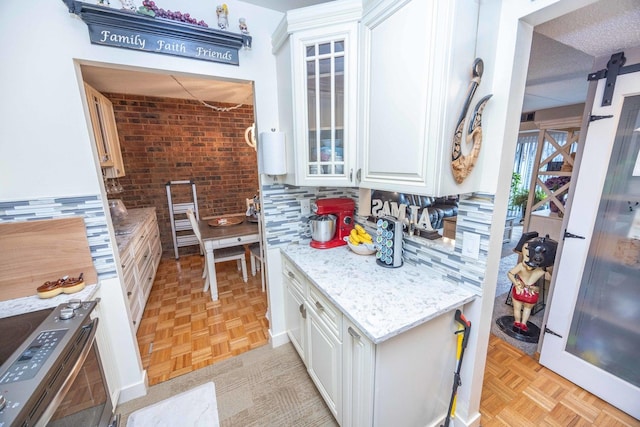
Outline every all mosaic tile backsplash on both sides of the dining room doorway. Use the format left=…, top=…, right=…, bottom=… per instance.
left=0, top=190, right=494, bottom=290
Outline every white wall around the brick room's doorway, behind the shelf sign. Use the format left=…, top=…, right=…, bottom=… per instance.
left=0, top=0, right=282, bottom=400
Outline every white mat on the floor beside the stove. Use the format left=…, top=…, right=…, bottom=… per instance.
left=127, top=382, right=220, bottom=427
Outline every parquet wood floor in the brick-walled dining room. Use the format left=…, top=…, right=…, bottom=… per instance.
left=137, top=254, right=269, bottom=385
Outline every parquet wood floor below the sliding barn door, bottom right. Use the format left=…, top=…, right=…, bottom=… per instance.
left=480, top=335, right=640, bottom=427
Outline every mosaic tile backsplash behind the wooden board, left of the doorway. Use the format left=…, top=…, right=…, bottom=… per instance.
left=0, top=195, right=117, bottom=280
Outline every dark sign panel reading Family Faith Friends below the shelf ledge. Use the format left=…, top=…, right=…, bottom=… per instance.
left=88, top=24, right=239, bottom=65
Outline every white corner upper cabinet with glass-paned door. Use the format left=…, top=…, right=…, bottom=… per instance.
left=273, top=0, right=362, bottom=186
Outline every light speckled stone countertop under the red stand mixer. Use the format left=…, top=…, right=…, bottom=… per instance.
left=281, top=244, right=476, bottom=344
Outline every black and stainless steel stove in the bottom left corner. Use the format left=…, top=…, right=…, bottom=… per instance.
left=0, top=300, right=118, bottom=427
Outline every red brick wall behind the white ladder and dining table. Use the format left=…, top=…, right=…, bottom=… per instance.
left=105, top=94, right=259, bottom=256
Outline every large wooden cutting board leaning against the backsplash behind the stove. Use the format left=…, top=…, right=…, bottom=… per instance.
left=0, top=217, right=98, bottom=301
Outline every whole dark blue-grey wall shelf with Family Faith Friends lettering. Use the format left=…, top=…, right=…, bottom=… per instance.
left=62, top=0, right=251, bottom=65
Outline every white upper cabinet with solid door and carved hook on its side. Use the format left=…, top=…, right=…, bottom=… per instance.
left=358, top=0, right=486, bottom=196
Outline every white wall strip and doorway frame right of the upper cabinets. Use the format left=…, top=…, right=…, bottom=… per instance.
left=456, top=0, right=595, bottom=426
